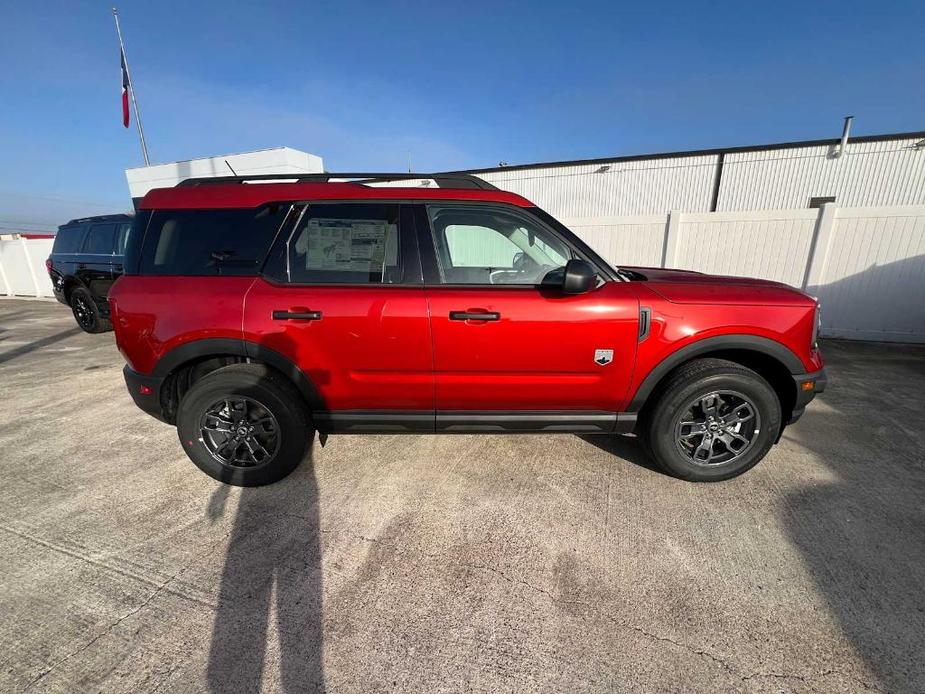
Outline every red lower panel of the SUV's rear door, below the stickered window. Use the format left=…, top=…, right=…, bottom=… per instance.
left=244, top=279, right=434, bottom=411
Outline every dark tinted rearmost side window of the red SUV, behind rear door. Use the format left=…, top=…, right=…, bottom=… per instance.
left=140, top=203, right=291, bottom=276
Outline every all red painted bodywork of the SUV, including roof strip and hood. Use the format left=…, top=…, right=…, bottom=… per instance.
left=109, top=183, right=823, bottom=424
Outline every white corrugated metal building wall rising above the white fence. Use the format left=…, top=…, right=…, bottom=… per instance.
left=476, top=137, right=925, bottom=218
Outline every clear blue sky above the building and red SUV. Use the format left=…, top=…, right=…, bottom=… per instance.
left=0, top=0, right=925, bottom=234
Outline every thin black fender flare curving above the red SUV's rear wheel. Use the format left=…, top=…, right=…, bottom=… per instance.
left=151, top=337, right=324, bottom=411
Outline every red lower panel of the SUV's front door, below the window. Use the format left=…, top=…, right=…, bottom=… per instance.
left=427, top=282, right=639, bottom=412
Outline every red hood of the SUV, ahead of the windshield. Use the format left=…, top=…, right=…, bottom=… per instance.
left=621, top=266, right=814, bottom=306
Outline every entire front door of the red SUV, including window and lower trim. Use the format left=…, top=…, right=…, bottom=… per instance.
left=418, top=203, right=639, bottom=431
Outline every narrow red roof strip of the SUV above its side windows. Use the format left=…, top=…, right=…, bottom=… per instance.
left=139, top=183, right=533, bottom=210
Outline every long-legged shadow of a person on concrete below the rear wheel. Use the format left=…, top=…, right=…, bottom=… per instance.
left=207, top=447, right=324, bottom=692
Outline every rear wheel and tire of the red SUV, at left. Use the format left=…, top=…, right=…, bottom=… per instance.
left=177, top=364, right=312, bottom=487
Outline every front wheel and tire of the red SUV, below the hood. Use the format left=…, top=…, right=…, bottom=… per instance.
left=643, top=359, right=781, bottom=482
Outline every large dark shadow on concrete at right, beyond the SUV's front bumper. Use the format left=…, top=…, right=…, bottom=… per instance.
left=784, top=343, right=925, bottom=692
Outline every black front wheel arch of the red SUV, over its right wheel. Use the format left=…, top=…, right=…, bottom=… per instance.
left=627, top=335, right=805, bottom=421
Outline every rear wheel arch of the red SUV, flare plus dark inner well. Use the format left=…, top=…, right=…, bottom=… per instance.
left=151, top=338, right=323, bottom=424
